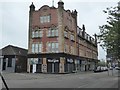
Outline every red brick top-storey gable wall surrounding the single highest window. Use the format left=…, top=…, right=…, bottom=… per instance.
left=32, top=5, right=58, bottom=28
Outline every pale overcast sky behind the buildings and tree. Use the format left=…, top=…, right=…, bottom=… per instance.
left=0, top=0, right=120, bottom=59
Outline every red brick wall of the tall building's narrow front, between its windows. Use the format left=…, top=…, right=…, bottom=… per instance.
left=32, top=5, right=58, bottom=52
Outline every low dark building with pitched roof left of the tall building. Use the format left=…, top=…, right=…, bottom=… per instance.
left=0, top=45, right=28, bottom=72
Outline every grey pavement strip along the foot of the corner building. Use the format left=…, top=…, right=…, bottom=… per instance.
left=2, top=71, right=93, bottom=80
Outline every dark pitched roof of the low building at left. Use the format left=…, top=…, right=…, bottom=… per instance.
left=0, top=45, right=28, bottom=56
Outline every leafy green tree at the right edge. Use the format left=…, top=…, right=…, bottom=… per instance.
left=97, top=2, right=120, bottom=61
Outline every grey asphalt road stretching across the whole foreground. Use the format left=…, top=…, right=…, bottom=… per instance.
left=3, top=71, right=118, bottom=88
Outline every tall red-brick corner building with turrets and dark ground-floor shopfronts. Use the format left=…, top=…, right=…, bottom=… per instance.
left=27, top=0, right=98, bottom=73
